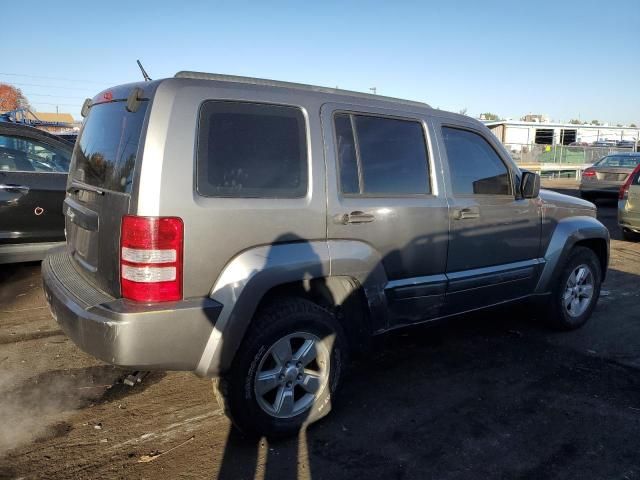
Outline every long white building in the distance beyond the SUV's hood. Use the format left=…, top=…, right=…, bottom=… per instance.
left=484, top=120, right=640, bottom=151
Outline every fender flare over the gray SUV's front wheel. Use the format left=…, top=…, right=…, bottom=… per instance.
left=535, top=216, right=609, bottom=294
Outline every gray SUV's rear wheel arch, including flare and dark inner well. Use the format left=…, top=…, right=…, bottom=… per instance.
left=194, top=241, right=386, bottom=377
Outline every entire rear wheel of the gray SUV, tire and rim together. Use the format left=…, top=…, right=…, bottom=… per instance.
left=216, top=298, right=347, bottom=438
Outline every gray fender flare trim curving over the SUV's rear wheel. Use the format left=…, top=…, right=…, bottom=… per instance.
left=194, top=240, right=386, bottom=377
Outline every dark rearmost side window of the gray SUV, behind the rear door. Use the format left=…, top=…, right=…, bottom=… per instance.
left=197, top=101, right=307, bottom=198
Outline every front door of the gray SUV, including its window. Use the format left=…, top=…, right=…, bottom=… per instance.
left=438, top=121, right=542, bottom=314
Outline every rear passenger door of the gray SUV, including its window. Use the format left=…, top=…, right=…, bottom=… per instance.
left=322, top=104, right=449, bottom=326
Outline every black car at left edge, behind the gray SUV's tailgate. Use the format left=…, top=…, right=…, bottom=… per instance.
left=0, top=122, right=73, bottom=264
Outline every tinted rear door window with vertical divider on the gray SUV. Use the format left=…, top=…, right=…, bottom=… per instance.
left=334, top=113, right=431, bottom=195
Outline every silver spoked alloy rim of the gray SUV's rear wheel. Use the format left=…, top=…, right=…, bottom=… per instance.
left=254, top=332, right=329, bottom=418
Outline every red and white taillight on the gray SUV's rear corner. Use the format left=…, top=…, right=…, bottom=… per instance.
left=120, top=215, right=184, bottom=302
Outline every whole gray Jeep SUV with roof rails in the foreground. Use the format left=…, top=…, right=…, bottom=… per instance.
left=42, top=72, right=609, bottom=436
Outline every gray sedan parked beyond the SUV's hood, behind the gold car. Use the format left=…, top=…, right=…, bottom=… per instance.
left=580, top=152, right=640, bottom=200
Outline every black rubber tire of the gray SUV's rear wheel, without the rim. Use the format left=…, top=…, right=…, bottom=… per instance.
left=214, top=297, right=348, bottom=438
